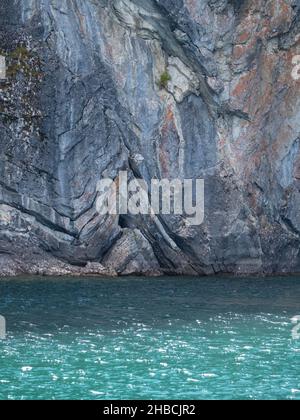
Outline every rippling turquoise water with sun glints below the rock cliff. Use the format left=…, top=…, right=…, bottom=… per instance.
left=0, top=278, right=300, bottom=399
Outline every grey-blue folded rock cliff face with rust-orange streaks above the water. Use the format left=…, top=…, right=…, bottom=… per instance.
left=0, top=0, right=300, bottom=274
